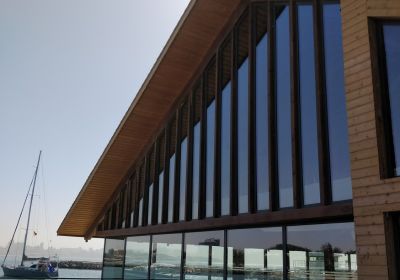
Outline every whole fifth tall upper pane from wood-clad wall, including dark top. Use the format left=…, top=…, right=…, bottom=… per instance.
left=237, top=15, right=249, bottom=213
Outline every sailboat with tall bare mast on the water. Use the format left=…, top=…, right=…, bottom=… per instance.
left=1, top=151, right=58, bottom=279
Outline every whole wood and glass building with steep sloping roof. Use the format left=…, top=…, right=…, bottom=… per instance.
left=58, top=0, right=400, bottom=280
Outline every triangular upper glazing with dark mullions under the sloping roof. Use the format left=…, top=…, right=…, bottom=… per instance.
left=98, top=1, right=351, bottom=236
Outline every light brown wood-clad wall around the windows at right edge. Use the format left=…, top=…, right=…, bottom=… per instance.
left=341, top=0, right=400, bottom=280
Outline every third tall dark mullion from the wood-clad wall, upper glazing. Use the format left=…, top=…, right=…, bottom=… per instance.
left=267, top=1, right=279, bottom=211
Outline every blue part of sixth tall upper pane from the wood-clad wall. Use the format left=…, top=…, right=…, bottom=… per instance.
left=221, top=82, right=231, bottom=215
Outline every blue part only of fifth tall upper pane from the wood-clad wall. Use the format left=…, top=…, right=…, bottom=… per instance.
left=237, top=58, right=249, bottom=213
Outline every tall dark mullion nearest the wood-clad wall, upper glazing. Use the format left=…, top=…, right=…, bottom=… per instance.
left=313, top=0, right=332, bottom=205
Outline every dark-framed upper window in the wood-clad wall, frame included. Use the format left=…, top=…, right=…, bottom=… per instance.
left=371, top=21, right=400, bottom=178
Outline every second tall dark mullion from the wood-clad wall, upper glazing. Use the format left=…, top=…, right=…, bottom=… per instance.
left=289, top=0, right=303, bottom=208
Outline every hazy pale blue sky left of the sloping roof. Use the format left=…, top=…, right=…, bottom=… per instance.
left=0, top=0, right=188, bottom=252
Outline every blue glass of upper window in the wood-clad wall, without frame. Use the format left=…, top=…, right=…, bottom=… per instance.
left=383, top=24, right=400, bottom=176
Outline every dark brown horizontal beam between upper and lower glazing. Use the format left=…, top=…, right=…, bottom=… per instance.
left=95, top=202, right=353, bottom=237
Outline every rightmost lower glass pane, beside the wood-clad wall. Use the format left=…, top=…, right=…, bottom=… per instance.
left=287, top=223, right=357, bottom=279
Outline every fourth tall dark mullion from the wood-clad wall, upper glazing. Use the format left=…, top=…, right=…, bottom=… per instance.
left=248, top=2, right=257, bottom=213
